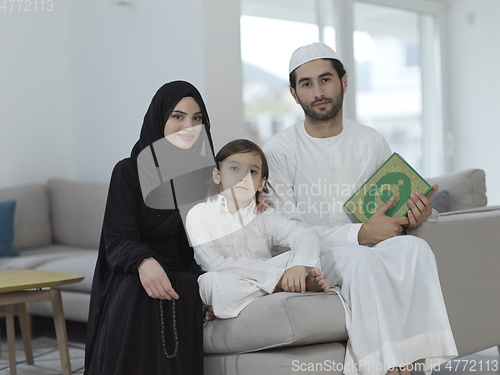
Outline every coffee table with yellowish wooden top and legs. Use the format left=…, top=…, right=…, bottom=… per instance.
left=0, top=270, right=84, bottom=375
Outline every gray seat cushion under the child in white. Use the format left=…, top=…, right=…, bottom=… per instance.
left=203, top=292, right=347, bottom=353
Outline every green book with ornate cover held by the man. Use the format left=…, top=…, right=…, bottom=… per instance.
left=344, top=152, right=434, bottom=223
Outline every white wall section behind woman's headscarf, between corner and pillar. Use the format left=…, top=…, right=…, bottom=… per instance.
left=69, top=0, right=205, bottom=181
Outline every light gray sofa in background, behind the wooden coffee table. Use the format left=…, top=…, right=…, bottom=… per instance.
left=0, top=179, right=108, bottom=322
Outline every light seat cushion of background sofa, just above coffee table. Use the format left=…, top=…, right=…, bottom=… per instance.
left=0, top=245, right=97, bottom=272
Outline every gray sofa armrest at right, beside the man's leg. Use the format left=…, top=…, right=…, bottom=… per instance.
left=408, top=206, right=500, bottom=356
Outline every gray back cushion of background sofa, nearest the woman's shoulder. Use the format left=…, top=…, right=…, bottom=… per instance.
left=47, top=179, right=108, bottom=248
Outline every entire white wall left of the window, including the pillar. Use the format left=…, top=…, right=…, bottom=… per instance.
left=0, top=0, right=243, bottom=186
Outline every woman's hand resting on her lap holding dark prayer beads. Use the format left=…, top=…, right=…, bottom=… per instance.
left=137, top=258, right=179, bottom=301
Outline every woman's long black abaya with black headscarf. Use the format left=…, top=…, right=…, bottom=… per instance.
left=85, top=82, right=213, bottom=375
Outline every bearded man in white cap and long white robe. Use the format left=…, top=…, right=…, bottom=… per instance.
left=264, top=43, right=457, bottom=375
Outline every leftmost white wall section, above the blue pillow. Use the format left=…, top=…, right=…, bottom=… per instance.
left=0, top=2, right=72, bottom=186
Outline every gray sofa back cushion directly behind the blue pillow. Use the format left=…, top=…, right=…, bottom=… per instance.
left=0, top=184, right=52, bottom=250
